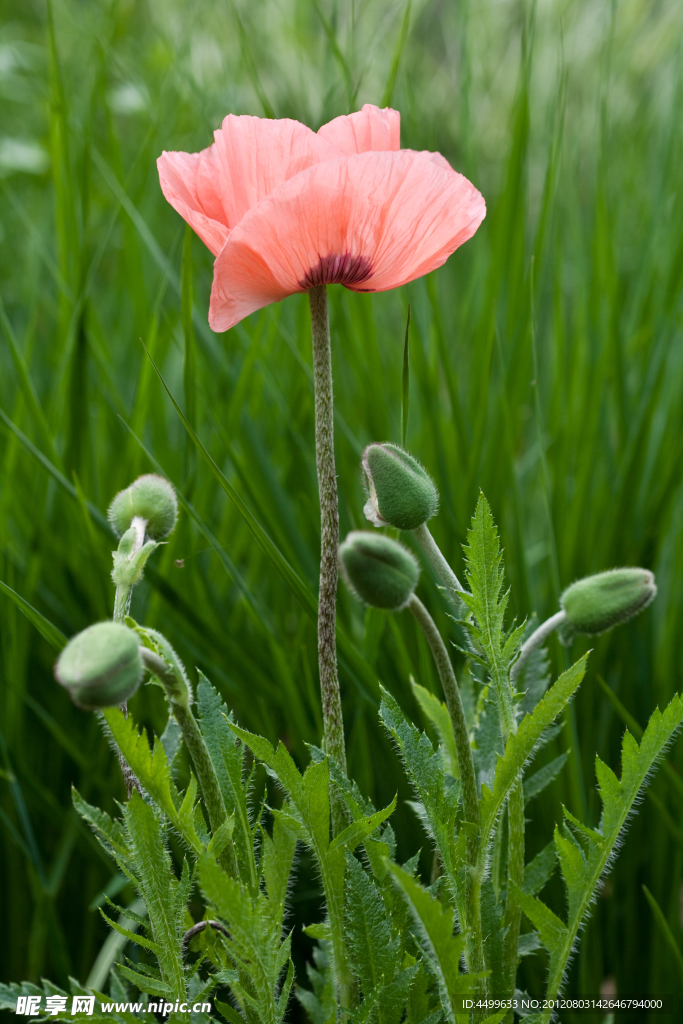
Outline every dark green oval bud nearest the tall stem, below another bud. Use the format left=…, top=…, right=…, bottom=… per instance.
left=339, top=530, right=420, bottom=611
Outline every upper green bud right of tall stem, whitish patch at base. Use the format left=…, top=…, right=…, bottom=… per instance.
left=362, top=443, right=438, bottom=529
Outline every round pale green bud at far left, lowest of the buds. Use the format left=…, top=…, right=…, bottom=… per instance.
left=54, top=623, right=142, bottom=711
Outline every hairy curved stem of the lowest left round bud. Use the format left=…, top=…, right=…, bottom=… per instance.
left=140, top=647, right=240, bottom=879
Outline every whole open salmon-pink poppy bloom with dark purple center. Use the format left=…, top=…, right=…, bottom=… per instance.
left=158, top=103, right=486, bottom=331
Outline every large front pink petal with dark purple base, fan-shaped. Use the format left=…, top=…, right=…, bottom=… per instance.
left=209, top=150, right=485, bottom=331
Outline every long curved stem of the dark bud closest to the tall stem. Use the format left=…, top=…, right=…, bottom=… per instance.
left=408, top=598, right=485, bottom=991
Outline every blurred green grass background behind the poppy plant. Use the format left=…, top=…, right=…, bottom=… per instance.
left=0, top=0, right=683, bottom=1019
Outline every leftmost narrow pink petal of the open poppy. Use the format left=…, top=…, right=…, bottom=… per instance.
left=157, top=146, right=229, bottom=256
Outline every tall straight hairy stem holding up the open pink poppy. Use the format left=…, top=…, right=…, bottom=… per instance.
left=308, top=285, right=346, bottom=836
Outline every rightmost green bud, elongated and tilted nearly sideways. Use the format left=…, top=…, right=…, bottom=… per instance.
left=560, top=568, right=657, bottom=635
